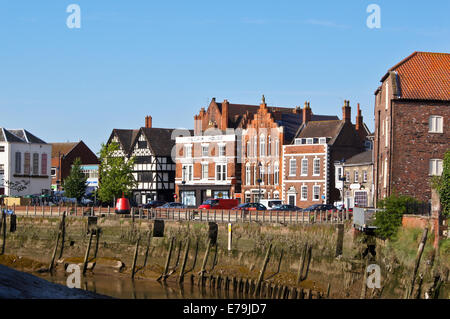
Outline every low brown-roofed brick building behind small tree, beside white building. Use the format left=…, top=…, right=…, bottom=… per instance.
left=51, top=141, right=99, bottom=191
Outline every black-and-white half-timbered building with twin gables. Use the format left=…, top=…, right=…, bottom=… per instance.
left=107, top=116, right=175, bottom=205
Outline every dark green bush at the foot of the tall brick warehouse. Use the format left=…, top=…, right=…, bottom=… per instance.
left=374, top=194, right=419, bottom=239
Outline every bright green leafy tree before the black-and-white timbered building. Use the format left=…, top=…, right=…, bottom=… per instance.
left=98, top=142, right=136, bottom=202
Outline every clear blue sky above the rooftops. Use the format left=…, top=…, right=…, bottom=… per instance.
left=0, top=0, right=450, bottom=151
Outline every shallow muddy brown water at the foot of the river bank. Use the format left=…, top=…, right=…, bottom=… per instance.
left=39, top=274, right=260, bottom=299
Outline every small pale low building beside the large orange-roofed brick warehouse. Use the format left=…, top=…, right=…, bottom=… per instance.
left=334, top=150, right=375, bottom=208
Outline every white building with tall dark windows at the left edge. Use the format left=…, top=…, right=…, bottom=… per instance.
left=0, top=127, right=52, bottom=196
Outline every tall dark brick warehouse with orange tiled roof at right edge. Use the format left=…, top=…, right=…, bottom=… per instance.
left=374, top=52, right=450, bottom=201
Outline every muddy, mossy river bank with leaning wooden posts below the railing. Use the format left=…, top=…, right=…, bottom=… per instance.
left=0, top=217, right=446, bottom=298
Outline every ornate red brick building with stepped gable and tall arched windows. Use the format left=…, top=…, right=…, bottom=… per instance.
left=242, top=96, right=337, bottom=202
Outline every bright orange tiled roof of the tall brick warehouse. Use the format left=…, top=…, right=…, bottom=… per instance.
left=381, top=52, right=450, bottom=101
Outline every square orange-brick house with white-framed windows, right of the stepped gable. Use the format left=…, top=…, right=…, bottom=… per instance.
left=282, top=101, right=369, bottom=208
